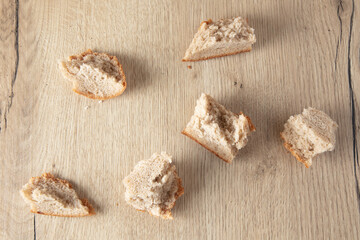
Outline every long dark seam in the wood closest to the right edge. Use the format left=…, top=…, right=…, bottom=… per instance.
left=348, top=0, right=360, bottom=215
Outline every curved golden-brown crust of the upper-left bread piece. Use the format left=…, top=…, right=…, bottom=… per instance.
left=65, top=49, right=127, bottom=100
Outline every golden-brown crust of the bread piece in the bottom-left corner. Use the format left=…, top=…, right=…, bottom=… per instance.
left=25, top=173, right=96, bottom=217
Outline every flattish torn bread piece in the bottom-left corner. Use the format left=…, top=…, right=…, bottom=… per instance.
left=20, top=173, right=95, bottom=217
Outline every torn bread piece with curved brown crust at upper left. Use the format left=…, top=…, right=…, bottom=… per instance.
left=60, top=49, right=126, bottom=100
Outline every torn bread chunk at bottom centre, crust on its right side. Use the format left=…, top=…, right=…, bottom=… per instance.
left=123, top=152, right=184, bottom=219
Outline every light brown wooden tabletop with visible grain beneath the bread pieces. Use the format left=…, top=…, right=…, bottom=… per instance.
left=0, top=0, right=360, bottom=240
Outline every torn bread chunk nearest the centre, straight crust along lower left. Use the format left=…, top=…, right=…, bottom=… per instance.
left=182, top=93, right=255, bottom=163
